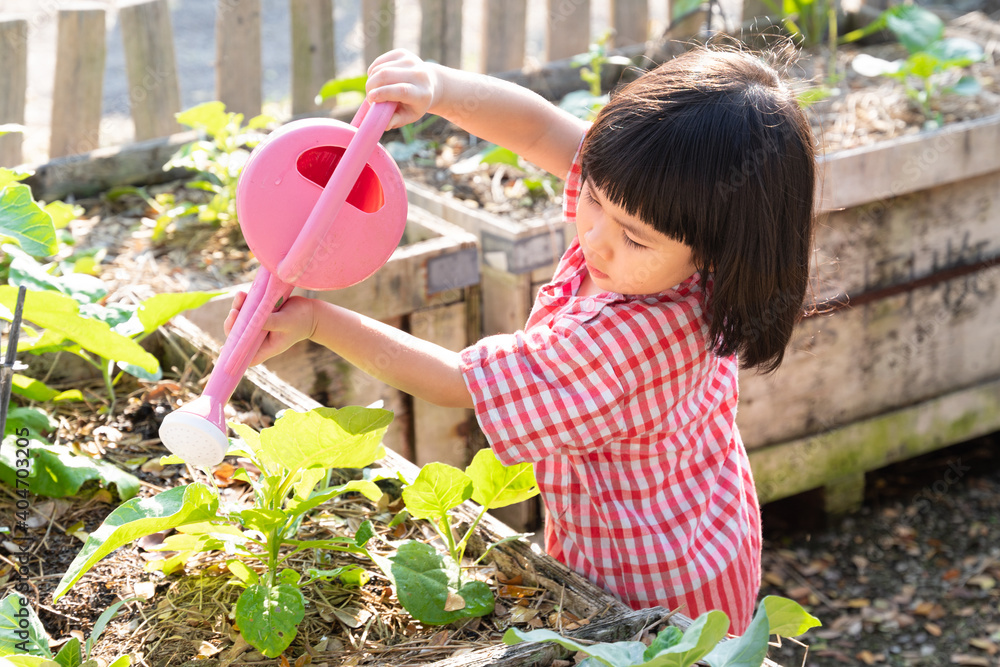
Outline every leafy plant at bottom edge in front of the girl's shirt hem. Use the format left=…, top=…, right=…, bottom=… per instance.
left=503, top=595, right=820, bottom=667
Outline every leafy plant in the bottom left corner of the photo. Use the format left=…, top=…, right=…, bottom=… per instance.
left=0, top=593, right=132, bottom=667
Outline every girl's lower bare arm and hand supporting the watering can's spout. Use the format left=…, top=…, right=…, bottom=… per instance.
left=225, top=292, right=473, bottom=408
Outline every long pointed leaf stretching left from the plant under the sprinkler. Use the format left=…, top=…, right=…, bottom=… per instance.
left=52, top=483, right=219, bottom=601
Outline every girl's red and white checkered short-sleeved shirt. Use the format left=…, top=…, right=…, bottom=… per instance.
left=462, top=145, right=760, bottom=632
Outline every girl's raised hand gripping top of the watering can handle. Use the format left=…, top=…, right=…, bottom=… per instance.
left=365, top=49, right=439, bottom=129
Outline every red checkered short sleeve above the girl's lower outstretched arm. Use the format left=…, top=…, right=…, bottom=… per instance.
left=461, top=326, right=624, bottom=465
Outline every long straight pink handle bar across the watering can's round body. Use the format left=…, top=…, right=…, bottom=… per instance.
left=275, top=100, right=396, bottom=284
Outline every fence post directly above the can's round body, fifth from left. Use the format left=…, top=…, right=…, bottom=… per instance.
left=292, top=0, right=337, bottom=115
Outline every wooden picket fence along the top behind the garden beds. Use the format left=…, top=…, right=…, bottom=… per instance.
left=0, top=0, right=692, bottom=166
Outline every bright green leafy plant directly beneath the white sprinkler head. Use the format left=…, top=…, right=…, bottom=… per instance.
left=53, top=407, right=392, bottom=658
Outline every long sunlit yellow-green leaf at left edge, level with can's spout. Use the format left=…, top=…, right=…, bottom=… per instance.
left=0, top=285, right=160, bottom=373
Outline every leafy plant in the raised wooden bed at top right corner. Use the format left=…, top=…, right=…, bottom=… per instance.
left=842, top=5, right=985, bottom=129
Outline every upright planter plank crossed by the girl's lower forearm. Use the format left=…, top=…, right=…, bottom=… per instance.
left=410, top=302, right=472, bottom=469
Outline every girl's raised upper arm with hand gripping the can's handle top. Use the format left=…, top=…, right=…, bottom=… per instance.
left=367, top=49, right=587, bottom=178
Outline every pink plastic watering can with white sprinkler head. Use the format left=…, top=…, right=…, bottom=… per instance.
left=160, top=100, right=406, bottom=465
